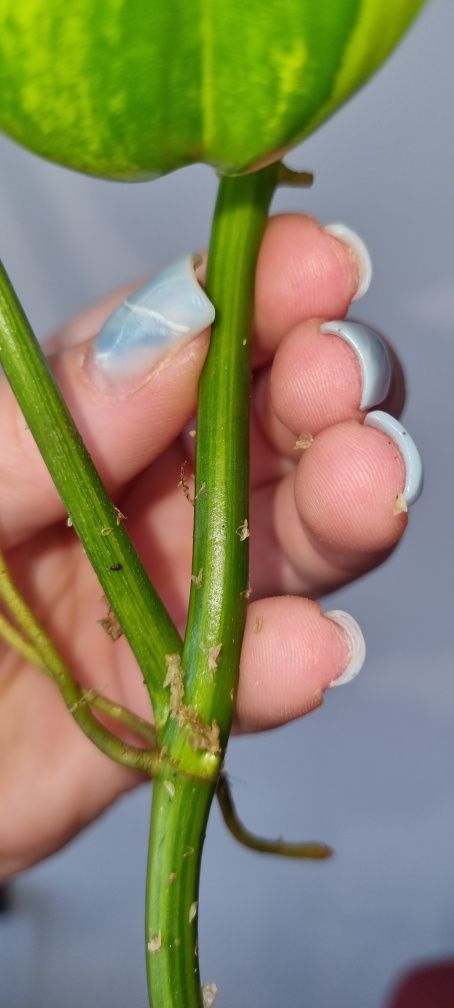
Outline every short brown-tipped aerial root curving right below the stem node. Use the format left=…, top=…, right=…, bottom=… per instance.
left=216, top=773, right=333, bottom=861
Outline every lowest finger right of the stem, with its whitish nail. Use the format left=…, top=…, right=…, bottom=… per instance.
left=236, top=596, right=365, bottom=732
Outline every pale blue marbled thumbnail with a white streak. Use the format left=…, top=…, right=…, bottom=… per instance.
left=87, top=255, right=215, bottom=394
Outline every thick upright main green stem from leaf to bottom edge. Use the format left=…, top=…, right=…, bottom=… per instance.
left=146, top=164, right=278, bottom=1008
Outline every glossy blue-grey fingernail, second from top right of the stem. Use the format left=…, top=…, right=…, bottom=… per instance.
left=320, top=320, right=391, bottom=409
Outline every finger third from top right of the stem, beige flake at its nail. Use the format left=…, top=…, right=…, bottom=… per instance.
left=250, top=414, right=421, bottom=595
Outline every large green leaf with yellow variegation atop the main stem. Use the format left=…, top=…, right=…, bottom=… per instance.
left=0, top=0, right=424, bottom=179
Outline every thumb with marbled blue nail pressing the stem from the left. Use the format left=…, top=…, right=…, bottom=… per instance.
left=0, top=256, right=214, bottom=547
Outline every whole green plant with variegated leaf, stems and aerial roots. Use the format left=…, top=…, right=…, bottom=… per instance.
left=0, top=0, right=424, bottom=1008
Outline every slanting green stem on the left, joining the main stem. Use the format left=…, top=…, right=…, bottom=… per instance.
left=0, top=264, right=182, bottom=725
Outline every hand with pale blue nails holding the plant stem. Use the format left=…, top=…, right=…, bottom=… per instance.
left=0, top=217, right=418, bottom=877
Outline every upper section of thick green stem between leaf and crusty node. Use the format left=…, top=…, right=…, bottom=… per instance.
left=159, top=164, right=278, bottom=772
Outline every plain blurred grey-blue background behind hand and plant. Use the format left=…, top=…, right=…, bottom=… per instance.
left=0, top=0, right=454, bottom=1008
